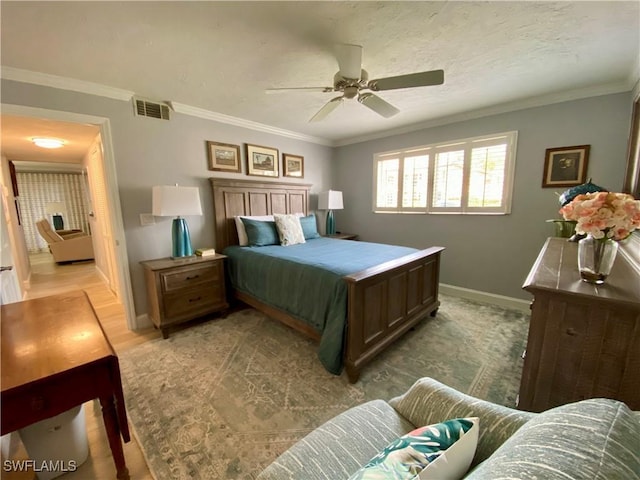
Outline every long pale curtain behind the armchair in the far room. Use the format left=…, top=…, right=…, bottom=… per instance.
left=16, top=172, right=90, bottom=253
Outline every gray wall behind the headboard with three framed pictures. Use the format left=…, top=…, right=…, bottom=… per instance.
left=2, top=80, right=333, bottom=315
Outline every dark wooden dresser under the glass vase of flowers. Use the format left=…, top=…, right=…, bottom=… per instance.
left=518, top=238, right=640, bottom=412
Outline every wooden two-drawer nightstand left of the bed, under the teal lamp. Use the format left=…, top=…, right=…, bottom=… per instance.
left=140, top=254, right=229, bottom=338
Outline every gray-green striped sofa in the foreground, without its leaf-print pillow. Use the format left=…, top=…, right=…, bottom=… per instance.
left=258, top=378, right=640, bottom=480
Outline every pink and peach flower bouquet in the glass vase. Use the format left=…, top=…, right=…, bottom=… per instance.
left=560, top=192, right=640, bottom=241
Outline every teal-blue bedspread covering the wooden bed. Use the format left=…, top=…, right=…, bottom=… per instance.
left=223, top=237, right=417, bottom=375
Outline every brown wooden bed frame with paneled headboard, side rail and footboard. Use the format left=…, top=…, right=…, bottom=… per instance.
left=211, top=178, right=444, bottom=383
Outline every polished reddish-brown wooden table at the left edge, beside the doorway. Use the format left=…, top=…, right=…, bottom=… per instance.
left=0, top=291, right=130, bottom=480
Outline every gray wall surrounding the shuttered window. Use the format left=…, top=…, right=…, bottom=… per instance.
left=331, top=92, right=632, bottom=299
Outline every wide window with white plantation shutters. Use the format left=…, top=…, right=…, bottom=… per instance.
left=373, top=132, right=517, bottom=214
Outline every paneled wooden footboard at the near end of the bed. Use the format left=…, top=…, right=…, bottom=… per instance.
left=345, top=247, right=444, bottom=383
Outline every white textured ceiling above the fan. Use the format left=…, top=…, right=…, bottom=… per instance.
left=0, top=1, right=640, bottom=144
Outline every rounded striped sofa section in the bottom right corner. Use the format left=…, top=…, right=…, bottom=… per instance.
left=466, top=398, right=640, bottom=480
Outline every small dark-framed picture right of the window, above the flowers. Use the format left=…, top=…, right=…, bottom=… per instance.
left=542, top=145, right=590, bottom=188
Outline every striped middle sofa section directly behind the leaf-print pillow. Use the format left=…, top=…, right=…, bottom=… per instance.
left=389, top=377, right=536, bottom=465
